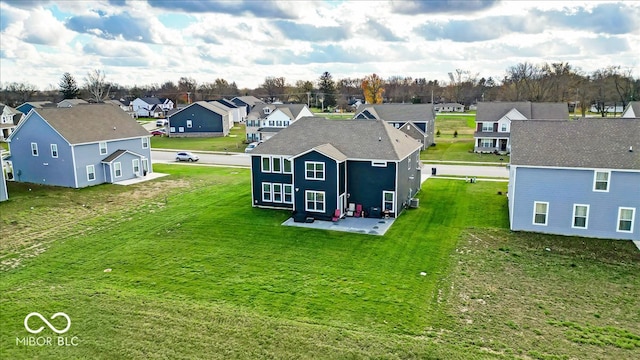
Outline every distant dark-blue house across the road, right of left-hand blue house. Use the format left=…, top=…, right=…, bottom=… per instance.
left=169, top=101, right=229, bottom=137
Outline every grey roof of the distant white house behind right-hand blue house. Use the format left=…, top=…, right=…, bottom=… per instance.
left=476, top=101, right=569, bottom=122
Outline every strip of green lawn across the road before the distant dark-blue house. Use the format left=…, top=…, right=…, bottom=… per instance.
left=151, top=124, right=247, bottom=152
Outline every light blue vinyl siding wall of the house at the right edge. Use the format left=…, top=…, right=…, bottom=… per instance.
left=509, top=167, right=640, bottom=240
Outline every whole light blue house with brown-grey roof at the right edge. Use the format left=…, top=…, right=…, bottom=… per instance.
left=508, top=118, right=640, bottom=241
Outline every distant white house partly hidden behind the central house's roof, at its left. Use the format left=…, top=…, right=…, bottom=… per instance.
left=245, top=104, right=313, bottom=142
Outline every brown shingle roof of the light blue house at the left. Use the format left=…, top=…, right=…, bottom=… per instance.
left=16, top=104, right=150, bottom=144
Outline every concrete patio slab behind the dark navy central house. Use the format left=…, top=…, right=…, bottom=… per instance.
left=282, top=217, right=395, bottom=236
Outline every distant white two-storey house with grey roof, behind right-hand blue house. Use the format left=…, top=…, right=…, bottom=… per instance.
left=473, top=101, right=569, bottom=153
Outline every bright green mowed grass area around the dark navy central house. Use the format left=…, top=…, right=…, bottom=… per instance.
left=0, top=166, right=506, bottom=357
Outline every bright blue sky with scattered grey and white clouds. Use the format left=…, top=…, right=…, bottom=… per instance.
left=0, top=0, right=640, bottom=90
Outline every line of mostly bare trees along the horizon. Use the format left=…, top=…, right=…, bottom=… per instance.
left=0, top=62, right=640, bottom=116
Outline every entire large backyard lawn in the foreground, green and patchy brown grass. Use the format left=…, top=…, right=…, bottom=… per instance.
left=0, top=165, right=640, bottom=359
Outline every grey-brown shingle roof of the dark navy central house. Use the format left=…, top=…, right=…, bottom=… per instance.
left=252, top=117, right=422, bottom=160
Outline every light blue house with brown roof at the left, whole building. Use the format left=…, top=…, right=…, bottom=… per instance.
left=9, top=104, right=152, bottom=188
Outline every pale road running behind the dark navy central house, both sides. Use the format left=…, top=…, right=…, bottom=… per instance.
left=151, top=150, right=509, bottom=178
